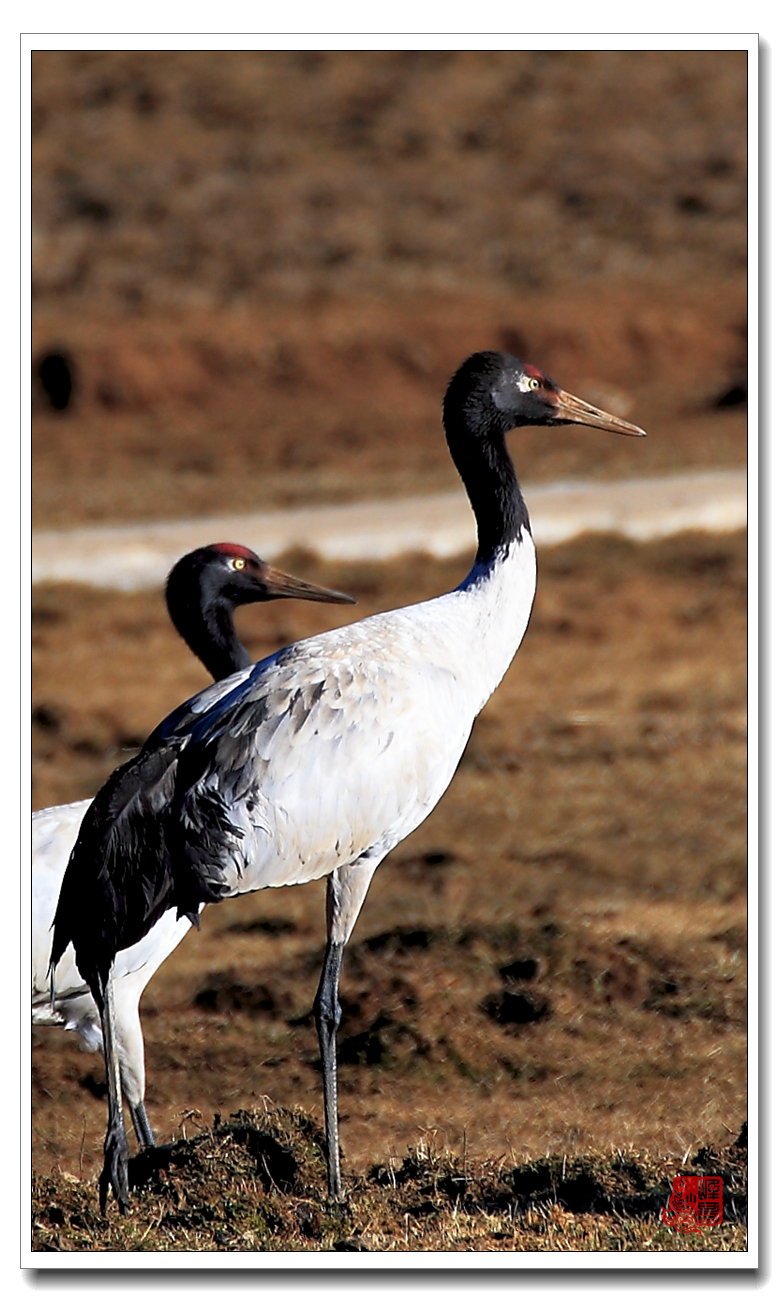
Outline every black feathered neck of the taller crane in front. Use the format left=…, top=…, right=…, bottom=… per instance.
left=444, top=387, right=530, bottom=565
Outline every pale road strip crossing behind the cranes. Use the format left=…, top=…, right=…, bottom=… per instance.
left=33, top=470, right=746, bottom=591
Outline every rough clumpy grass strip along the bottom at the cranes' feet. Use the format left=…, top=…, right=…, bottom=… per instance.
left=33, top=1108, right=746, bottom=1253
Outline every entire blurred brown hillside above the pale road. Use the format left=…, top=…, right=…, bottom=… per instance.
left=33, top=51, right=746, bottom=527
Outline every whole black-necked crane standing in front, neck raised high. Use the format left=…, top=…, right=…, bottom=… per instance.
left=52, top=352, right=644, bottom=1211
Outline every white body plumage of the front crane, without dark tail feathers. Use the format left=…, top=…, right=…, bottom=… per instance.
left=180, top=529, right=535, bottom=896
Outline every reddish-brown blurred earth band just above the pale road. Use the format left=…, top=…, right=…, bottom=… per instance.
left=33, top=283, right=746, bottom=529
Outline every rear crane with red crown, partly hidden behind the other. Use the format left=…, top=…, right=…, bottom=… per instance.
left=33, top=543, right=353, bottom=1146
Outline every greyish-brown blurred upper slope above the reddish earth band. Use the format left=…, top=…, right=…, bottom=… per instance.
left=33, top=51, right=746, bottom=309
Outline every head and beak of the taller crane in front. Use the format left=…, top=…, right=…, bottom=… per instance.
left=444, top=353, right=645, bottom=440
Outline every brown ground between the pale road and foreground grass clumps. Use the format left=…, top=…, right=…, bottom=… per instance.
left=33, top=535, right=746, bottom=1249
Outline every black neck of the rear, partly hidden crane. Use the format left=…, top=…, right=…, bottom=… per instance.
left=165, top=568, right=251, bottom=682
